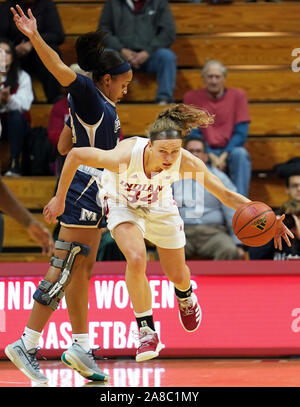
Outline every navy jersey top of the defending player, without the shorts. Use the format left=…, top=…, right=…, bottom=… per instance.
left=67, top=74, right=120, bottom=150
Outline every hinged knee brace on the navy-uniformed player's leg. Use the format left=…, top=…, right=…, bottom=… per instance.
left=33, top=240, right=90, bottom=310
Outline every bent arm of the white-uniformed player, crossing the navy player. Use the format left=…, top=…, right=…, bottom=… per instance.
left=43, top=139, right=135, bottom=223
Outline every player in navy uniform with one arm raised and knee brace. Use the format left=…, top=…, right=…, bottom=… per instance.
left=5, top=6, right=132, bottom=383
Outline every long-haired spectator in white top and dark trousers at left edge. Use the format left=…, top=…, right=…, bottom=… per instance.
left=0, top=38, right=33, bottom=176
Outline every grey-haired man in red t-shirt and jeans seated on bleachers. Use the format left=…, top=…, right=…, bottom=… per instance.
left=183, top=60, right=251, bottom=196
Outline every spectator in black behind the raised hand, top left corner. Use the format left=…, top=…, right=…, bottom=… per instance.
left=0, top=0, right=64, bottom=103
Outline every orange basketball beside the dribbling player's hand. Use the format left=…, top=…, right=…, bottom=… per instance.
left=232, top=201, right=276, bottom=247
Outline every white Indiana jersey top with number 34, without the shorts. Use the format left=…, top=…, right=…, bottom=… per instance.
left=100, top=137, right=181, bottom=211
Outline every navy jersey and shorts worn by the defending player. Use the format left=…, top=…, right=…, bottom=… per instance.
left=60, top=74, right=120, bottom=228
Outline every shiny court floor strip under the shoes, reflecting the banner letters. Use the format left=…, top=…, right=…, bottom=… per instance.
left=0, top=358, right=300, bottom=388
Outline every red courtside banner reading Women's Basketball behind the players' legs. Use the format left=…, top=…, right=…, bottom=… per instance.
left=0, top=262, right=300, bottom=357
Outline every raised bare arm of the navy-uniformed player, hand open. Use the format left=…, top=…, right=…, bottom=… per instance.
left=10, top=5, right=76, bottom=87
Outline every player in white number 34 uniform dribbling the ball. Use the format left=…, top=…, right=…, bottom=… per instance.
left=44, top=104, right=293, bottom=361
